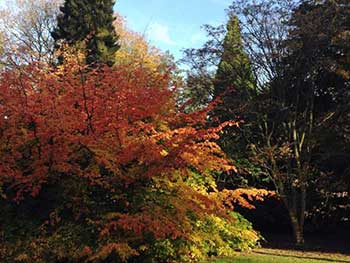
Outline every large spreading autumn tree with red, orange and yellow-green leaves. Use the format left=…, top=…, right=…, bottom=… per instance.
left=0, top=49, right=267, bottom=263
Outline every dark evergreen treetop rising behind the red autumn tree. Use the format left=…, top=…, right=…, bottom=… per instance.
left=52, top=0, right=119, bottom=65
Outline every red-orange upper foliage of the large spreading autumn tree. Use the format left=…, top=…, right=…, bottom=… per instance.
left=0, top=56, right=226, bottom=200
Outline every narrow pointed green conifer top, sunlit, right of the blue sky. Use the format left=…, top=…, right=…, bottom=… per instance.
left=214, top=15, right=255, bottom=121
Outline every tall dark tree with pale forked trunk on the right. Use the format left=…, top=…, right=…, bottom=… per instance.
left=252, top=1, right=349, bottom=244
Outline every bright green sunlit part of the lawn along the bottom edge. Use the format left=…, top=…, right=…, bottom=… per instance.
left=207, top=253, right=350, bottom=263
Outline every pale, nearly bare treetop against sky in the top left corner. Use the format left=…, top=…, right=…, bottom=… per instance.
left=0, top=0, right=62, bottom=67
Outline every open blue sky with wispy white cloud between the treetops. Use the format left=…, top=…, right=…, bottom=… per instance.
left=115, top=0, right=231, bottom=59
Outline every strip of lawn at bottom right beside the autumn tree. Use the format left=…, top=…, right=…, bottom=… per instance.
left=202, top=249, right=350, bottom=263
